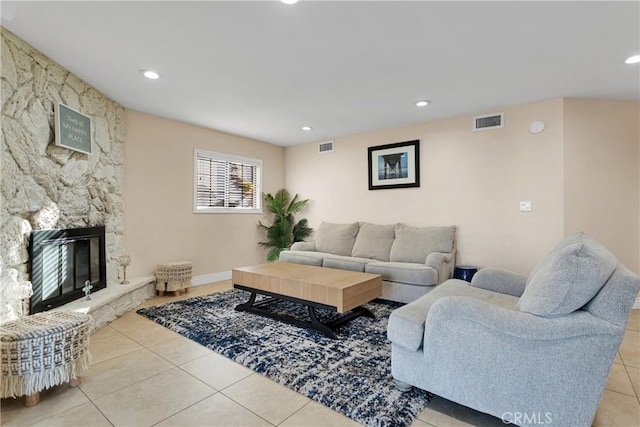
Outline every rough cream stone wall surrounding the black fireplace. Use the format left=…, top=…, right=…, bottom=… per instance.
left=0, top=28, right=125, bottom=314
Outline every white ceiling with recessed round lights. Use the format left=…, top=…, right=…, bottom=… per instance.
left=0, top=0, right=640, bottom=146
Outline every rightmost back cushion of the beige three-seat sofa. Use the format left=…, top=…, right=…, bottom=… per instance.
left=389, top=224, right=456, bottom=264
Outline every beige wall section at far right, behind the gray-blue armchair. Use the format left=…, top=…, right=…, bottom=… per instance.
left=563, top=99, right=640, bottom=273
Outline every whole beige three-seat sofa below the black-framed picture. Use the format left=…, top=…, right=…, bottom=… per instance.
left=280, top=222, right=456, bottom=303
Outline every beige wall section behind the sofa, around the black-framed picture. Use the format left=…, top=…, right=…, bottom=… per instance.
left=285, top=99, right=564, bottom=273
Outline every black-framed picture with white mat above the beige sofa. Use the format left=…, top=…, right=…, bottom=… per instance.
left=368, top=140, right=420, bottom=190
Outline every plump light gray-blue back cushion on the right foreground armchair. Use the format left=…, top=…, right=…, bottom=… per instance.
left=518, top=234, right=617, bottom=317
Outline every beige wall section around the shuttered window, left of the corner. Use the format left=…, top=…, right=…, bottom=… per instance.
left=125, top=110, right=284, bottom=276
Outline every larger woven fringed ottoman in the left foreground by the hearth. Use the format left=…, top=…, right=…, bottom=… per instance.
left=0, top=311, right=91, bottom=398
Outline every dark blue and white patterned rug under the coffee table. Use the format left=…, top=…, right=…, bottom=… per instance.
left=137, top=289, right=430, bottom=426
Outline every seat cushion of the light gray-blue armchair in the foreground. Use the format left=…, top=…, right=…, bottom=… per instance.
left=387, top=279, right=518, bottom=351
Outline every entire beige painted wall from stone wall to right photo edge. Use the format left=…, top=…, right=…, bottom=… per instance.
left=125, top=99, right=640, bottom=276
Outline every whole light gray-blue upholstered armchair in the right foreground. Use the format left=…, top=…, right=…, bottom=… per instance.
left=388, top=234, right=640, bottom=426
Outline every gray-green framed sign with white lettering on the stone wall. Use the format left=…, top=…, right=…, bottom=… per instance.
left=55, top=102, right=93, bottom=154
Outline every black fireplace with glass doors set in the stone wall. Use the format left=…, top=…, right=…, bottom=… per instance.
left=29, top=226, right=107, bottom=314
